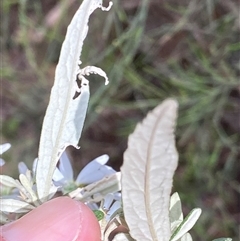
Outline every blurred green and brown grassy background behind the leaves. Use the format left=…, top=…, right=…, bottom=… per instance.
left=1, top=0, right=240, bottom=241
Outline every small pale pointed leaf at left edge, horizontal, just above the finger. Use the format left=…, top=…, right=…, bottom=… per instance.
left=0, top=199, right=34, bottom=213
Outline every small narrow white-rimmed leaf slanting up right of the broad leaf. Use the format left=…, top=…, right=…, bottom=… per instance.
left=170, top=208, right=202, bottom=241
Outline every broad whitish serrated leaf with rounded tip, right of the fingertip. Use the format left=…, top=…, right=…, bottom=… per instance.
left=121, top=99, right=178, bottom=241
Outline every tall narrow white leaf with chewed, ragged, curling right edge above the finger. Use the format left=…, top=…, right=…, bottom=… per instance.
left=36, top=0, right=112, bottom=201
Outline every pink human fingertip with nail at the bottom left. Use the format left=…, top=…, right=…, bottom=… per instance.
left=0, top=197, right=101, bottom=241
